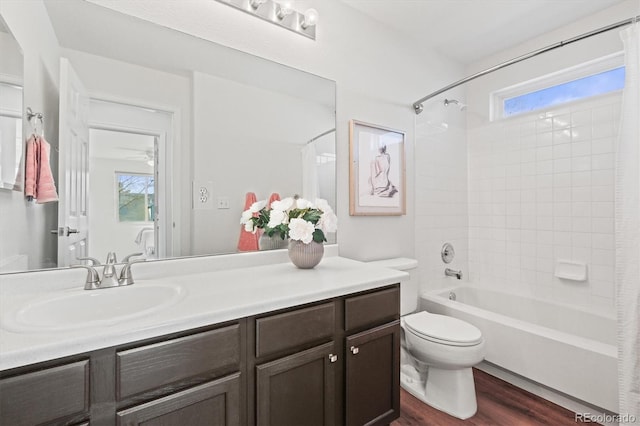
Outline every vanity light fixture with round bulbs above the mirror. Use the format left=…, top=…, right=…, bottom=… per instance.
left=215, top=0, right=319, bottom=40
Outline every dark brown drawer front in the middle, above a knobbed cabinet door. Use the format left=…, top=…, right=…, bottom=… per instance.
left=256, top=302, right=336, bottom=358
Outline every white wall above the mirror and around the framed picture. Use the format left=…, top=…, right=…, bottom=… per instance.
left=86, top=0, right=461, bottom=259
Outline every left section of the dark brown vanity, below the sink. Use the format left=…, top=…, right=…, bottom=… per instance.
left=0, top=320, right=246, bottom=426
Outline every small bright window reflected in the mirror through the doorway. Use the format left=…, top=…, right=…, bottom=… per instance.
left=116, top=173, right=156, bottom=222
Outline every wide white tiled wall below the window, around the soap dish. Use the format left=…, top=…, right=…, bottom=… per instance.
left=464, top=94, right=621, bottom=313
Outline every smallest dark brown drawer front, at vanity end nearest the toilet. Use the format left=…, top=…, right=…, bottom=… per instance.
left=344, top=285, right=400, bottom=331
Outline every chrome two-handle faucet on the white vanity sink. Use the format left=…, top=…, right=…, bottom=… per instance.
left=71, top=252, right=145, bottom=290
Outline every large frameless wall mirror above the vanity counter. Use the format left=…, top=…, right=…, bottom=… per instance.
left=1, top=0, right=336, bottom=272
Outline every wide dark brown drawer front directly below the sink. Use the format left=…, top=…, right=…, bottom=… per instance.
left=116, top=324, right=241, bottom=400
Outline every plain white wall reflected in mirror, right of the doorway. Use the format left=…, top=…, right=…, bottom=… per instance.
left=192, top=72, right=334, bottom=254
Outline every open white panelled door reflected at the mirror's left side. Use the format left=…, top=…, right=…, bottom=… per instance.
left=57, top=58, right=89, bottom=267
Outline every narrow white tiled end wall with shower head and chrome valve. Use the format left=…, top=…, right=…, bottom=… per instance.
left=415, top=104, right=470, bottom=290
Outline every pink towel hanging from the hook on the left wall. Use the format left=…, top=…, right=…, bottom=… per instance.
left=24, top=135, right=58, bottom=204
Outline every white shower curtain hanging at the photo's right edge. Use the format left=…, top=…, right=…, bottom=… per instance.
left=615, top=23, right=640, bottom=424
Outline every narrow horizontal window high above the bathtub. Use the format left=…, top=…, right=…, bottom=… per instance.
left=492, top=54, right=625, bottom=119
